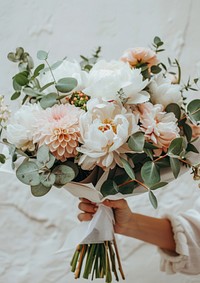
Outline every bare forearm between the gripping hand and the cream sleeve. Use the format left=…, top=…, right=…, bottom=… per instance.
left=118, top=213, right=176, bottom=252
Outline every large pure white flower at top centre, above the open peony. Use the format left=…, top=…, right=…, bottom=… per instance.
left=83, top=60, right=149, bottom=104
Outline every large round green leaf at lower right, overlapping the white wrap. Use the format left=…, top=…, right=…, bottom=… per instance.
left=141, top=161, right=160, bottom=186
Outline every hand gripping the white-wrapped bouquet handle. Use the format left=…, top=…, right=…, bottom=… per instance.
left=78, top=199, right=133, bottom=234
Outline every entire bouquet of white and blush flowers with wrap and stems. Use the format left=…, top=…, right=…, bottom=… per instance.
left=0, top=37, right=200, bottom=282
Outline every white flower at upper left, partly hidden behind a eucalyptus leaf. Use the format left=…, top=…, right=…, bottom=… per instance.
left=39, top=59, right=88, bottom=92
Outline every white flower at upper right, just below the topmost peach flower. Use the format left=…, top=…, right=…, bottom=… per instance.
left=149, top=74, right=183, bottom=108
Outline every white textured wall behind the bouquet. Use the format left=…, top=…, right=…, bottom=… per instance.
left=0, top=0, right=200, bottom=283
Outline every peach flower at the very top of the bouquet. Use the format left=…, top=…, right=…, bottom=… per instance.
left=121, top=47, right=158, bottom=68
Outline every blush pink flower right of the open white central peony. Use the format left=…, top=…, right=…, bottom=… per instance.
left=138, top=102, right=179, bottom=155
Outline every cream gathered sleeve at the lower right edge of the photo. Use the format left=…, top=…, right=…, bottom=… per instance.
left=159, top=197, right=200, bottom=274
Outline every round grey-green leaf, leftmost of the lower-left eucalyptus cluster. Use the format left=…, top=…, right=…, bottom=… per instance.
left=16, top=161, right=40, bottom=186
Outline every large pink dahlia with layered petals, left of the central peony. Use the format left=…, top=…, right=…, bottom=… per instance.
left=34, top=104, right=84, bottom=161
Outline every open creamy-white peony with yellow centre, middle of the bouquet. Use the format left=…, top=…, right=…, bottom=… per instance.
left=78, top=98, right=139, bottom=170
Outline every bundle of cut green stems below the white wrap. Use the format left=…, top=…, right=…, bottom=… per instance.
left=71, top=239, right=125, bottom=283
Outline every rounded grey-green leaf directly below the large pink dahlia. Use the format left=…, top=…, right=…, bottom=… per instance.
left=52, top=165, right=76, bottom=185
